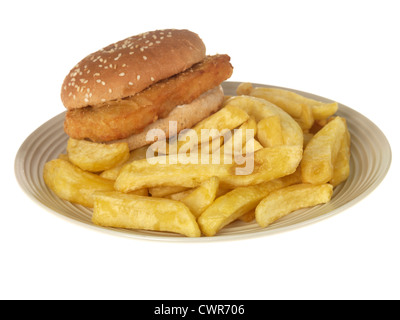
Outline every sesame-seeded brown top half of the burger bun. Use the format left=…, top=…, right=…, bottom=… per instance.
left=61, top=29, right=206, bottom=110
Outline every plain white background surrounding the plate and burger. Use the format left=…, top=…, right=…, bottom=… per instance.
left=0, top=0, right=400, bottom=299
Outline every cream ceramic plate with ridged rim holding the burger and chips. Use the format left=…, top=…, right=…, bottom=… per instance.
left=15, top=82, right=391, bottom=242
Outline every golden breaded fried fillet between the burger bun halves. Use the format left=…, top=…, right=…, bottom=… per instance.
left=64, top=55, right=233, bottom=142
